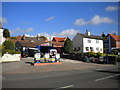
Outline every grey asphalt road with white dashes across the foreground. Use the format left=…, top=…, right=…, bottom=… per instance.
left=2, top=66, right=120, bottom=90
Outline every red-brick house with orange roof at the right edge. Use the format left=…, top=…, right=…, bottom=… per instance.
left=103, top=34, right=120, bottom=52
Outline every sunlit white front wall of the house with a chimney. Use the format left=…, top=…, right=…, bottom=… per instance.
left=83, top=38, right=103, bottom=53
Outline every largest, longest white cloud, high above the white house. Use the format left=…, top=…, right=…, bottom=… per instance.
left=75, top=15, right=113, bottom=26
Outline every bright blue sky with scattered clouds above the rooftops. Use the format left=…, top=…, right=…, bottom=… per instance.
left=1, top=2, right=118, bottom=38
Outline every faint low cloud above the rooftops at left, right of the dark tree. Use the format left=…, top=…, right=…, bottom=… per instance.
left=10, top=27, right=34, bottom=35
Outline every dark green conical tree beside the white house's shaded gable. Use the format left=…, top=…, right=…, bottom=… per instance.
left=64, top=38, right=73, bottom=53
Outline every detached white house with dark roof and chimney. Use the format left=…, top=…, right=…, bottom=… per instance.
left=73, top=30, right=103, bottom=53
